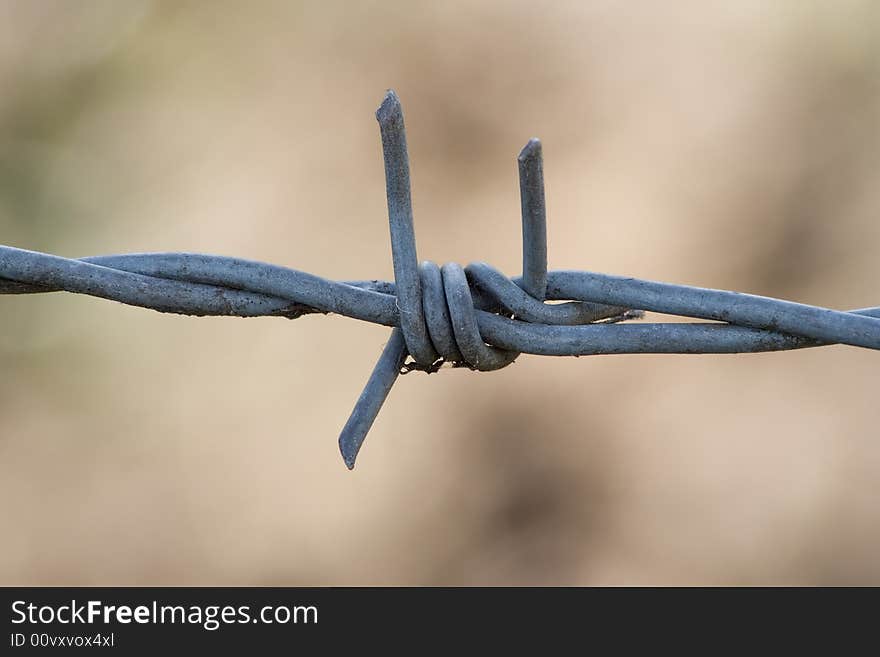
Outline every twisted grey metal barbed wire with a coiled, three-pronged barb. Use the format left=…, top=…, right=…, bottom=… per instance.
left=0, top=91, right=880, bottom=469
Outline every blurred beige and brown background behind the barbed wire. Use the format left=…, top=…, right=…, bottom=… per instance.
left=0, top=0, right=880, bottom=585
